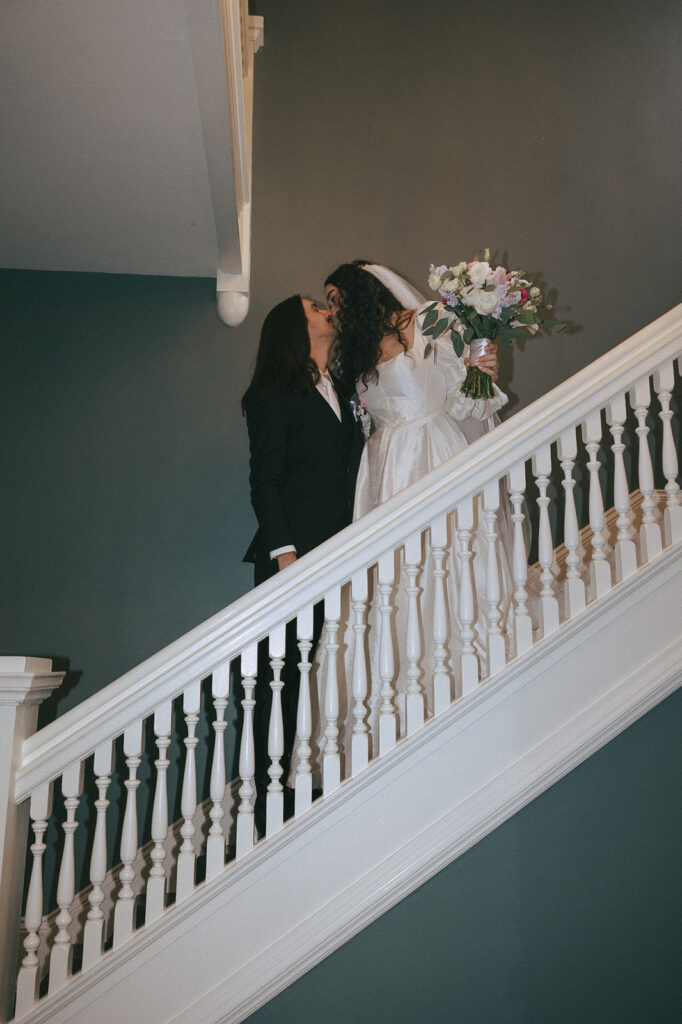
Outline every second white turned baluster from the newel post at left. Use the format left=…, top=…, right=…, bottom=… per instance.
left=47, top=763, right=83, bottom=995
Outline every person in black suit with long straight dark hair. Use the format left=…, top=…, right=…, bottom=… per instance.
left=242, top=295, right=364, bottom=834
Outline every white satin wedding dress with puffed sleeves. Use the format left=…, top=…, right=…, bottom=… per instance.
left=301, top=309, right=513, bottom=777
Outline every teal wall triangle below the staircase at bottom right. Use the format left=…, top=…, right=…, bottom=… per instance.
left=248, top=690, right=682, bottom=1024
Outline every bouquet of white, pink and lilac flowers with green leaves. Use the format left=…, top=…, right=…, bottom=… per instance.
left=422, top=249, right=566, bottom=398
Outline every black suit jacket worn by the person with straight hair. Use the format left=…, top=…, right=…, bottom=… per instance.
left=245, top=388, right=364, bottom=579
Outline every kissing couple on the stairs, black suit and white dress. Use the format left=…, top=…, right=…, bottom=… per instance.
left=242, top=260, right=513, bottom=833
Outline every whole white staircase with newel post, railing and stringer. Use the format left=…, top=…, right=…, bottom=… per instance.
left=0, top=306, right=682, bottom=1024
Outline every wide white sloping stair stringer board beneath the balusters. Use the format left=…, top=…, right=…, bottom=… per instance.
left=20, top=544, right=682, bottom=1024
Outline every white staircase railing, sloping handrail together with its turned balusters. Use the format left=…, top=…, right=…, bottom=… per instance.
left=3, top=306, right=682, bottom=1019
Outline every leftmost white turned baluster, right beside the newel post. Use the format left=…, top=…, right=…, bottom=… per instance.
left=15, top=782, right=52, bottom=1018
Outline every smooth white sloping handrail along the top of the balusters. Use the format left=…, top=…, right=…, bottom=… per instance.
left=14, top=305, right=682, bottom=802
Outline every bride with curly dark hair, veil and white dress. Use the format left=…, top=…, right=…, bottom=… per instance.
left=305, top=264, right=513, bottom=775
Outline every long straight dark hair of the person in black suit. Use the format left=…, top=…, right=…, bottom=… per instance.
left=242, top=295, right=319, bottom=413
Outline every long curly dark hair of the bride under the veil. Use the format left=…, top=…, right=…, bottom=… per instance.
left=325, top=259, right=410, bottom=391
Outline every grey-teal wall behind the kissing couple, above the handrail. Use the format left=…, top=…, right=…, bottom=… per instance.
left=0, top=0, right=682, bottom=714
